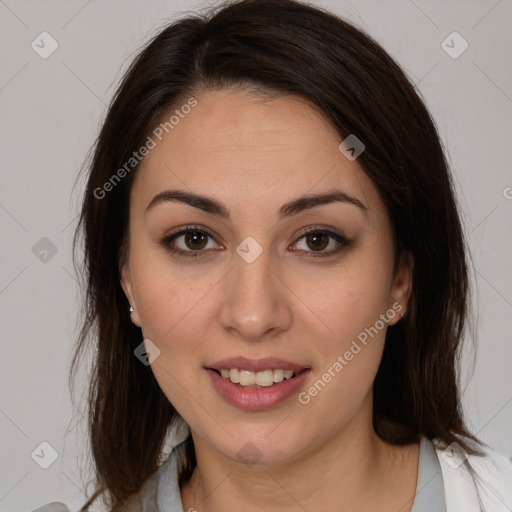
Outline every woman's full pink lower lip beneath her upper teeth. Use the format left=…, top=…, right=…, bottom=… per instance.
left=206, top=368, right=311, bottom=411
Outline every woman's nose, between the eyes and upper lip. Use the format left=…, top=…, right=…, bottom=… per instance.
left=218, top=242, right=293, bottom=341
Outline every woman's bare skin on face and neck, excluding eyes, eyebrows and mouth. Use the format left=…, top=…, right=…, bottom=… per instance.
left=122, top=90, right=419, bottom=512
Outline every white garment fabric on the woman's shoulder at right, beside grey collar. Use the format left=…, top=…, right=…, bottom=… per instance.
left=432, top=439, right=512, bottom=512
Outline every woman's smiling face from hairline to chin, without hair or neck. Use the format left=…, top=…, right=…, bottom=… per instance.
left=122, top=91, right=410, bottom=464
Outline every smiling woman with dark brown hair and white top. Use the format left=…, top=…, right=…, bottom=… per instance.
left=34, top=0, right=512, bottom=512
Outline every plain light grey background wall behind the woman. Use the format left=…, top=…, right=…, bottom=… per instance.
left=0, top=0, right=512, bottom=512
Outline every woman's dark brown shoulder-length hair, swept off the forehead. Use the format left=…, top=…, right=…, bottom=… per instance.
left=70, top=0, right=479, bottom=510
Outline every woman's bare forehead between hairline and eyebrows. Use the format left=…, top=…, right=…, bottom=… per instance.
left=132, top=90, right=379, bottom=218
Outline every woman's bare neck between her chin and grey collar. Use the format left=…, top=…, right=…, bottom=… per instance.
left=178, top=396, right=418, bottom=512
